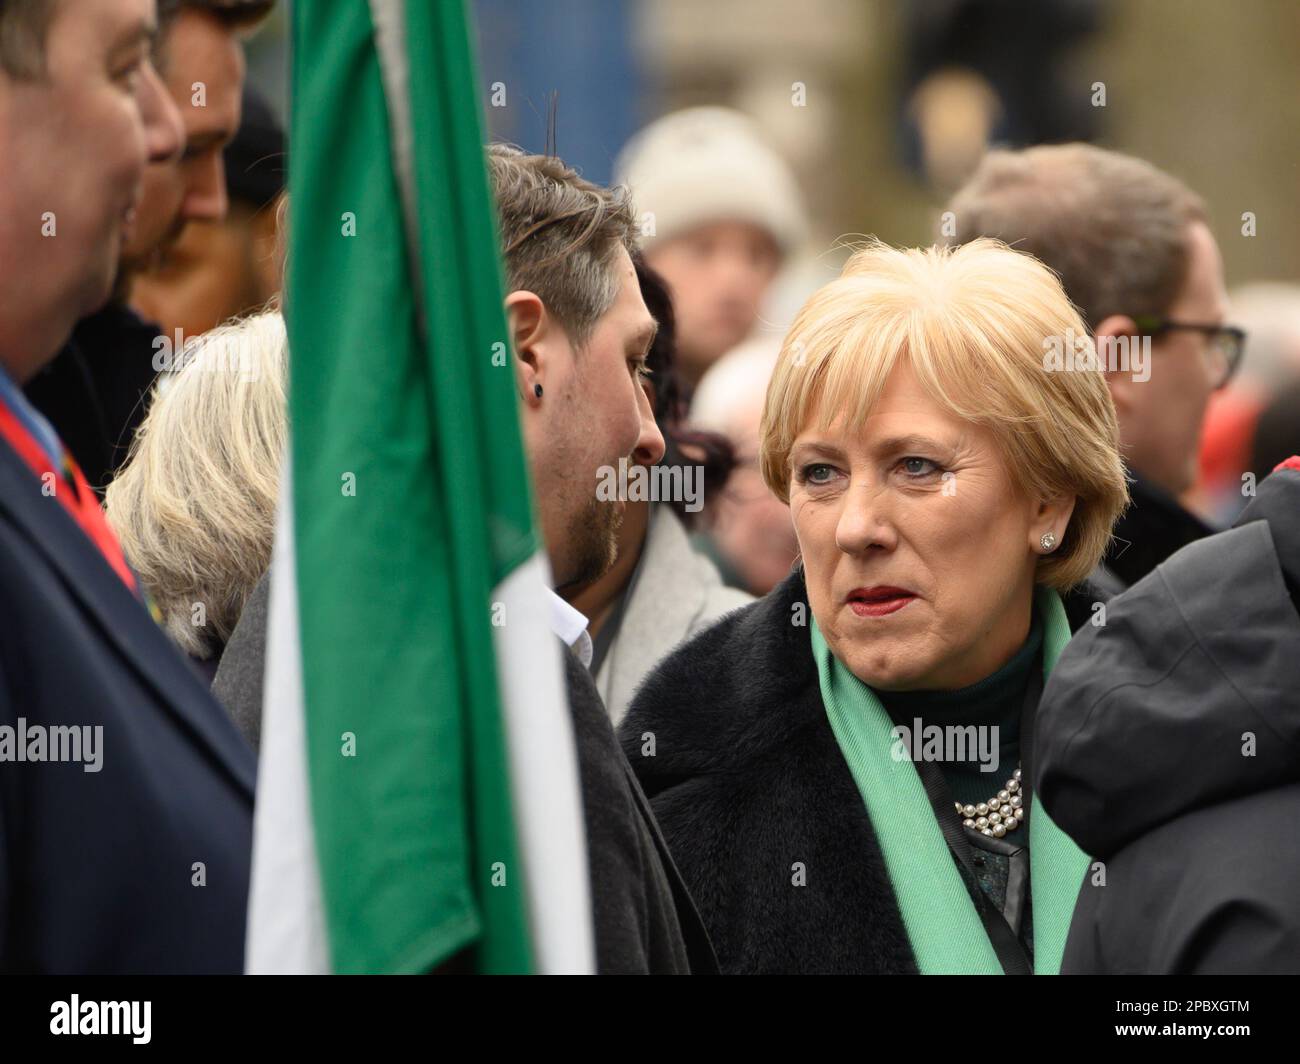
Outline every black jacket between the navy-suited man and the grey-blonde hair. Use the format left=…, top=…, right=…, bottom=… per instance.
left=23, top=303, right=159, bottom=492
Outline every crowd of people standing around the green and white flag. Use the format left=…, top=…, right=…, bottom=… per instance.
left=0, top=0, right=1300, bottom=974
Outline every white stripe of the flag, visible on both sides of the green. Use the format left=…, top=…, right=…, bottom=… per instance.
left=244, top=473, right=595, bottom=976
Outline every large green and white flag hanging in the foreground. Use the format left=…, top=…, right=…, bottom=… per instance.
left=248, top=0, right=592, bottom=972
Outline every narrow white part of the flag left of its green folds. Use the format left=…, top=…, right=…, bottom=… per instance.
left=244, top=455, right=332, bottom=976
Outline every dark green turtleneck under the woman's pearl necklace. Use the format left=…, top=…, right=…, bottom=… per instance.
left=876, top=610, right=1043, bottom=955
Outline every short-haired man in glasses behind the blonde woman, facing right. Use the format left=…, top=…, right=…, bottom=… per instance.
left=950, top=144, right=1245, bottom=593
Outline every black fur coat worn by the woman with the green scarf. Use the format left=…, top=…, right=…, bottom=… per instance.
left=619, top=571, right=1095, bottom=974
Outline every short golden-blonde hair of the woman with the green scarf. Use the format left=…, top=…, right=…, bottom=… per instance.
left=759, top=239, right=1128, bottom=591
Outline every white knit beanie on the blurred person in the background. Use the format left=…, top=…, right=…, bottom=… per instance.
left=615, top=107, right=807, bottom=255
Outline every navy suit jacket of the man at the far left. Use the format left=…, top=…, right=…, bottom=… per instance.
left=0, top=441, right=255, bottom=974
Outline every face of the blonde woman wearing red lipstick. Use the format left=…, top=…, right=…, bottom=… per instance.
left=790, top=363, right=1073, bottom=691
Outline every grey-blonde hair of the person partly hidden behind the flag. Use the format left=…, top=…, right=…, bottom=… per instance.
left=105, top=312, right=289, bottom=658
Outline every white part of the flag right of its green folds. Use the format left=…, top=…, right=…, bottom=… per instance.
left=493, top=554, right=595, bottom=976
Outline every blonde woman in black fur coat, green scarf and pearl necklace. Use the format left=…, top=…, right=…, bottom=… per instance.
left=621, top=239, right=1127, bottom=973
